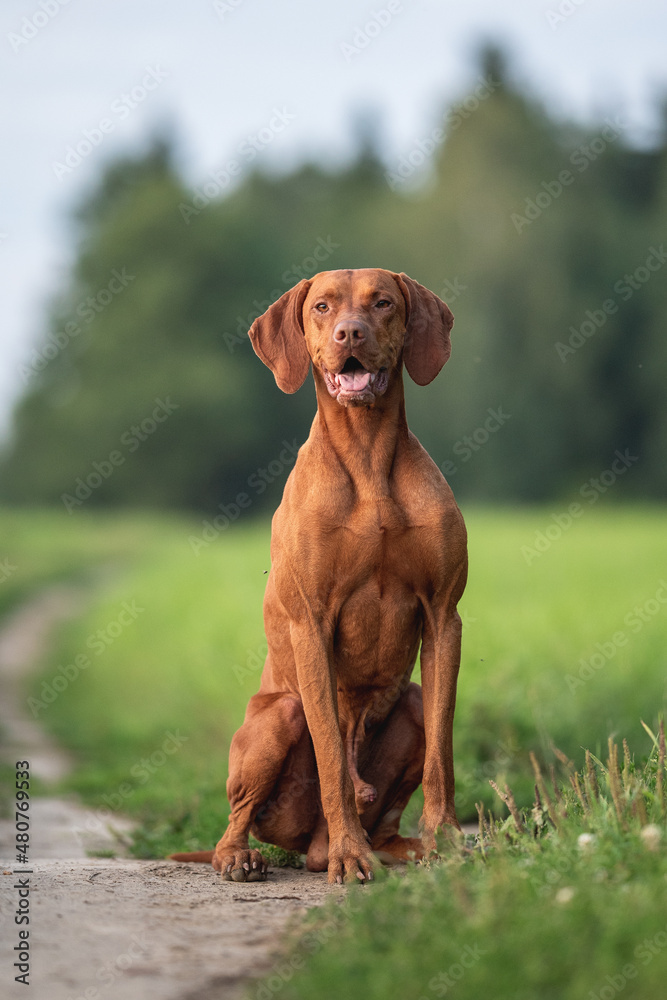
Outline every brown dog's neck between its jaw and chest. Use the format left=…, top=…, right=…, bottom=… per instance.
left=311, top=370, right=409, bottom=499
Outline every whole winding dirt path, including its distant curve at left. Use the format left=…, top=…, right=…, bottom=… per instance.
left=0, top=588, right=336, bottom=1000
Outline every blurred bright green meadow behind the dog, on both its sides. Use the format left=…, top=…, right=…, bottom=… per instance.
left=2, top=507, right=667, bottom=855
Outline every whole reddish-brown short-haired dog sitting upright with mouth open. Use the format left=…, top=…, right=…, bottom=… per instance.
left=174, top=269, right=467, bottom=882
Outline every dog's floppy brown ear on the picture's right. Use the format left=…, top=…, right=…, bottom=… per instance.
left=393, top=272, right=454, bottom=385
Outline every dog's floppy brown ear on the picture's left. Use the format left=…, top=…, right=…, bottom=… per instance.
left=248, top=278, right=310, bottom=392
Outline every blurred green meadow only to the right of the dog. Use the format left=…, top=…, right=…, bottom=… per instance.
left=448, top=507, right=667, bottom=815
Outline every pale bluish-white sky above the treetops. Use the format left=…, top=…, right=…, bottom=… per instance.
left=0, top=0, right=667, bottom=436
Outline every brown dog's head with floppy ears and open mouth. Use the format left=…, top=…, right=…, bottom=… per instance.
left=249, top=268, right=454, bottom=406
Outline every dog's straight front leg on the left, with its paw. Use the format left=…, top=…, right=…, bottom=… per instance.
left=290, top=622, right=377, bottom=883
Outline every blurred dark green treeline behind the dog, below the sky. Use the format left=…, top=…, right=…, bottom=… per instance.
left=0, top=53, right=667, bottom=516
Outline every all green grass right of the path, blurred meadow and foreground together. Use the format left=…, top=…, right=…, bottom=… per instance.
left=0, top=505, right=667, bottom=1000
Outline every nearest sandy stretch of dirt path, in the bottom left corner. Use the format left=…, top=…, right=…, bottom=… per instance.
left=2, top=858, right=330, bottom=1000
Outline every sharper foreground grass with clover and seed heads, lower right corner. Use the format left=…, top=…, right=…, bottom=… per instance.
left=272, top=743, right=667, bottom=1000
